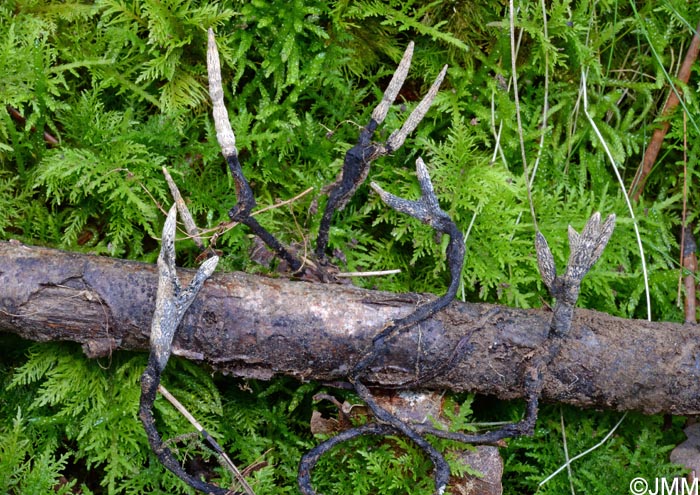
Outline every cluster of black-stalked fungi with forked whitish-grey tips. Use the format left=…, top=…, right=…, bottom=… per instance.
left=139, top=30, right=615, bottom=495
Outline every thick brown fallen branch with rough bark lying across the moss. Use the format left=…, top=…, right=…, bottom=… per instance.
left=0, top=242, right=700, bottom=414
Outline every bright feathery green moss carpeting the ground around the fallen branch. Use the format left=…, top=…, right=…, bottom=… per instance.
left=0, top=0, right=700, bottom=493
